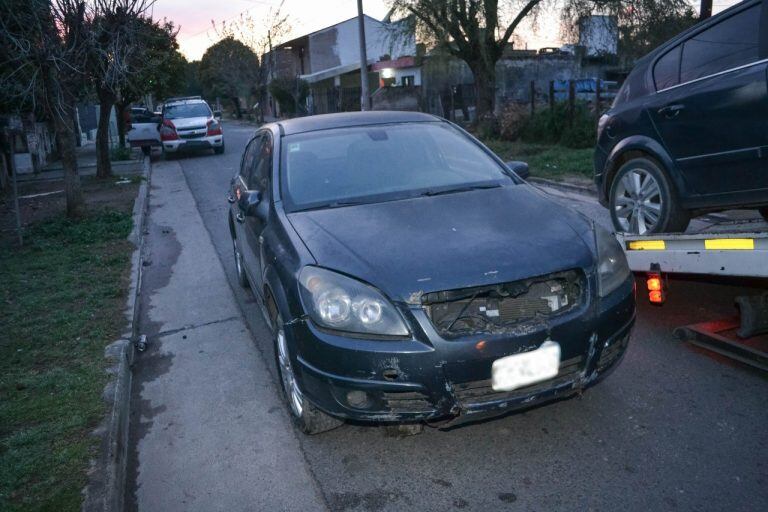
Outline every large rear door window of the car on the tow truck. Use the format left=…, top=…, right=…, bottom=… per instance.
left=680, top=4, right=760, bottom=82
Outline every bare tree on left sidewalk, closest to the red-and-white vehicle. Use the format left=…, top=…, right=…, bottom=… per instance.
left=88, top=0, right=154, bottom=178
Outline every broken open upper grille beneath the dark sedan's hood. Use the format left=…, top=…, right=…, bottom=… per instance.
left=422, top=270, right=586, bottom=339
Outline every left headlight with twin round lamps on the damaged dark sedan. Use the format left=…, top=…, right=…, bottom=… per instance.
left=299, top=266, right=409, bottom=336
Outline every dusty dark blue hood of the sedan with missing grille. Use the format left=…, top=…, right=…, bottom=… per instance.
left=288, top=185, right=594, bottom=303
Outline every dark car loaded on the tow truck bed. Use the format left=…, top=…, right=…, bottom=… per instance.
left=595, top=0, right=768, bottom=234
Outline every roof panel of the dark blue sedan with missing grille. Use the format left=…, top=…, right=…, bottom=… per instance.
left=276, top=110, right=441, bottom=135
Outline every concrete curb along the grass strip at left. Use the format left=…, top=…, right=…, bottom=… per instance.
left=82, top=158, right=152, bottom=512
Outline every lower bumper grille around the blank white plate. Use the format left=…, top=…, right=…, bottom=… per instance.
left=454, top=356, right=584, bottom=405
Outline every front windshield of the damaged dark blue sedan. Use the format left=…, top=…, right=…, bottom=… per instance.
left=281, top=123, right=514, bottom=211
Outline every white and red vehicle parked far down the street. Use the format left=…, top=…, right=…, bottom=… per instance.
left=160, top=96, right=224, bottom=155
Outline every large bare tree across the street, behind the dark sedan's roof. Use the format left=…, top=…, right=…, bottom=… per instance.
left=391, top=0, right=543, bottom=125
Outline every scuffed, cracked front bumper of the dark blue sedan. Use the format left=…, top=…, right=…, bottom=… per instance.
left=286, top=279, right=635, bottom=422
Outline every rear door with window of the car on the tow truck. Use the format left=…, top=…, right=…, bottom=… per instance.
left=647, top=3, right=768, bottom=194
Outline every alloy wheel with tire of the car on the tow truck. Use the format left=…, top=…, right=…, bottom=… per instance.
left=608, top=157, right=691, bottom=235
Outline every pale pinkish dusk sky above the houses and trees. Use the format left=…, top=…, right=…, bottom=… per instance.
left=152, top=0, right=736, bottom=60
